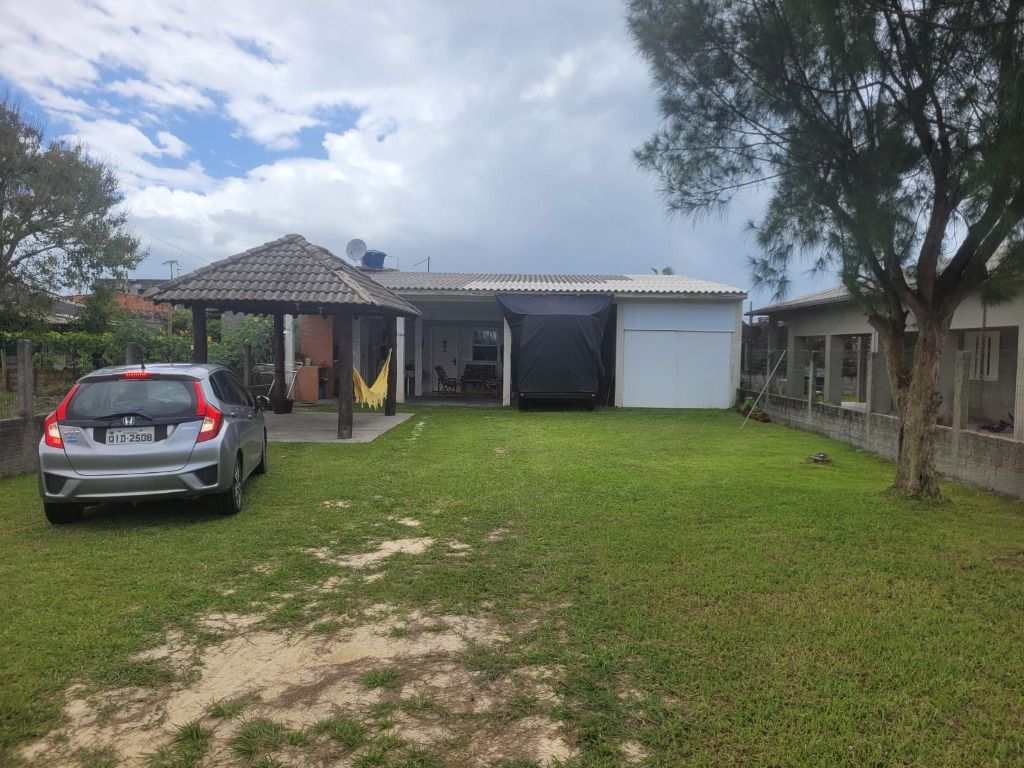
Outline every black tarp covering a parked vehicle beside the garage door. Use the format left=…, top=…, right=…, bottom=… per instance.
left=497, top=294, right=611, bottom=396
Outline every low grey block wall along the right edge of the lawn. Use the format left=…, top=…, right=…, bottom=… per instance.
left=742, top=391, right=1024, bottom=499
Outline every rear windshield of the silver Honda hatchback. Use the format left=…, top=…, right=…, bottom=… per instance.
left=67, top=378, right=197, bottom=420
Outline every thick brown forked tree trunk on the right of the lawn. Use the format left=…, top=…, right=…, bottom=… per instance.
left=881, top=315, right=951, bottom=499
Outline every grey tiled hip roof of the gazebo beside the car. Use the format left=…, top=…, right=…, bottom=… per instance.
left=145, top=234, right=420, bottom=314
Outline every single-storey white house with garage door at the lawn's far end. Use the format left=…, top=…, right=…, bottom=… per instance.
left=296, top=268, right=745, bottom=408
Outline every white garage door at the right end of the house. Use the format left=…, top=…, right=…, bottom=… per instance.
left=620, top=303, right=736, bottom=408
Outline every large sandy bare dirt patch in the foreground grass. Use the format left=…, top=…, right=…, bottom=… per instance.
left=22, top=603, right=569, bottom=768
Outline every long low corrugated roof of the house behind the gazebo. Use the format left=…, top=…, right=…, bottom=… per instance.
left=367, top=269, right=745, bottom=296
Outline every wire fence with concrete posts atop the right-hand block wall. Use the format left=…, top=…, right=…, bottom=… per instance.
left=740, top=346, right=1020, bottom=436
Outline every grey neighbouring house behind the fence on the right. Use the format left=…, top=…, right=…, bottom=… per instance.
left=744, top=287, right=1024, bottom=439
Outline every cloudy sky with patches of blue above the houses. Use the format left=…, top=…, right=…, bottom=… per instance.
left=0, top=0, right=831, bottom=300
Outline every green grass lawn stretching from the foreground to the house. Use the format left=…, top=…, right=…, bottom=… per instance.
left=0, top=409, right=1024, bottom=766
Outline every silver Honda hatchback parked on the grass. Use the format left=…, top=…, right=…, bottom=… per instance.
left=39, top=364, right=269, bottom=523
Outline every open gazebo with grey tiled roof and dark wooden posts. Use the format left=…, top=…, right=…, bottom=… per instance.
left=145, top=234, right=420, bottom=439
